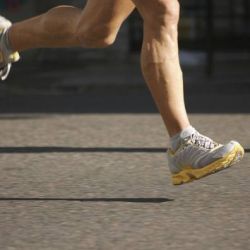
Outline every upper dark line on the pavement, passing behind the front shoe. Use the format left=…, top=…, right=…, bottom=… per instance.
left=0, top=147, right=250, bottom=154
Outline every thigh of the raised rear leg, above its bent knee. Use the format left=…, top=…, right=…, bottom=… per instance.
left=80, top=0, right=135, bottom=29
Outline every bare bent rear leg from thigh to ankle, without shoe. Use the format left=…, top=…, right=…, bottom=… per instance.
left=9, top=0, right=134, bottom=52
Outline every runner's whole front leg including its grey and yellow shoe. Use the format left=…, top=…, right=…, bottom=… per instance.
left=133, top=0, right=244, bottom=185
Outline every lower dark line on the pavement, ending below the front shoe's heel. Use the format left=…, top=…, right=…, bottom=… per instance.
left=0, top=197, right=174, bottom=203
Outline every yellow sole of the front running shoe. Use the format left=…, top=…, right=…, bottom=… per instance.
left=172, top=144, right=244, bottom=185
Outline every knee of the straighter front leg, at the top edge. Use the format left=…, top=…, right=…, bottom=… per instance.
left=143, top=0, right=180, bottom=27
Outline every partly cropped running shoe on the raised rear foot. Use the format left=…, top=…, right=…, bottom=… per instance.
left=0, top=16, right=20, bottom=80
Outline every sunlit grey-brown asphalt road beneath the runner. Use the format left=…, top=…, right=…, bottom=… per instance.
left=0, top=107, right=250, bottom=250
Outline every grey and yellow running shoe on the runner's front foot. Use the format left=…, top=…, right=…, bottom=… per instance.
left=168, top=129, right=244, bottom=185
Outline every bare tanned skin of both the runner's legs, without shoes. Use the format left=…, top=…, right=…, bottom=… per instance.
left=9, top=0, right=190, bottom=136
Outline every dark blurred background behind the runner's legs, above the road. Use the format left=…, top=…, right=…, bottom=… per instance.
left=0, top=0, right=250, bottom=112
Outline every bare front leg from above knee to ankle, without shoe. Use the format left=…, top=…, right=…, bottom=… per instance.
left=133, top=0, right=190, bottom=136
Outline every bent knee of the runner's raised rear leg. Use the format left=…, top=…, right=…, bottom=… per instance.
left=75, top=24, right=117, bottom=48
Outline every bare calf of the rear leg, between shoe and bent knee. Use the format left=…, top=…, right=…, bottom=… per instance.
left=9, top=6, right=81, bottom=52
